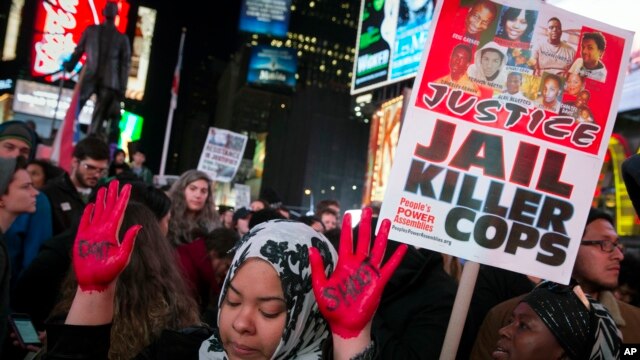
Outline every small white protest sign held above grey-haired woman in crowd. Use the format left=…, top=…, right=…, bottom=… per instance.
left=198, top=127, right=247, bottom=182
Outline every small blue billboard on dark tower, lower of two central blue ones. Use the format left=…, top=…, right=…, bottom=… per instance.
left=247, top=45, right=298, bottom=88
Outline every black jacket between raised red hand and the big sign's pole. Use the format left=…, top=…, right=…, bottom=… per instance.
left=371, top=241, right=456, bottom=359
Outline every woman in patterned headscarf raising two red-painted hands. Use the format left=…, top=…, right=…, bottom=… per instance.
left=48, top=184, right=407, bottom=359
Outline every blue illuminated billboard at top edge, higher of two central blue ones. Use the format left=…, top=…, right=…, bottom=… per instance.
left=239, top=0, right=291, bottom=37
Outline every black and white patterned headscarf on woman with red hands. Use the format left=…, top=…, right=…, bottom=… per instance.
left=199, top=220, right=338, bottom=359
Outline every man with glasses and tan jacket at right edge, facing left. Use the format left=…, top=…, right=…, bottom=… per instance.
left=471, top=208, right=640, bottom=359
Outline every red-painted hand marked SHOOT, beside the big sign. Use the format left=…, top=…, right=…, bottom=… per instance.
left=309, top=208, right=407, bottom=339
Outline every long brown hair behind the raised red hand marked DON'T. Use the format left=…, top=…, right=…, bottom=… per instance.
left=52, top=201, right=200, bottom=359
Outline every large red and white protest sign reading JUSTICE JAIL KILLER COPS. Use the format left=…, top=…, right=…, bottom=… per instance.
left=380, top=0, right=632, bottom=283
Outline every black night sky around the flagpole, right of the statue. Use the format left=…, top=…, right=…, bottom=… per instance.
left=132, top=0, right=241, bottom=173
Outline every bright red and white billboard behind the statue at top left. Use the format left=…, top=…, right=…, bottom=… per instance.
left=31, top=0, right=130, bottom=82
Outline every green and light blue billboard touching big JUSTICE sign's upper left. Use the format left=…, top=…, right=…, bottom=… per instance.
left=351, top=0, right=434, bottom=95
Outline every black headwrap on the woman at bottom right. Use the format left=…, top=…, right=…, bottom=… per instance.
left=522, top=281, right=621, bottom=359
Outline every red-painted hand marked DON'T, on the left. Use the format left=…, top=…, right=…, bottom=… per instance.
left=73, top=181, right=142, bottom=291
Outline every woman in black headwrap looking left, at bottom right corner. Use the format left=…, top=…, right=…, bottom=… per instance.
left=492, top=281, right=621, bottom=360
